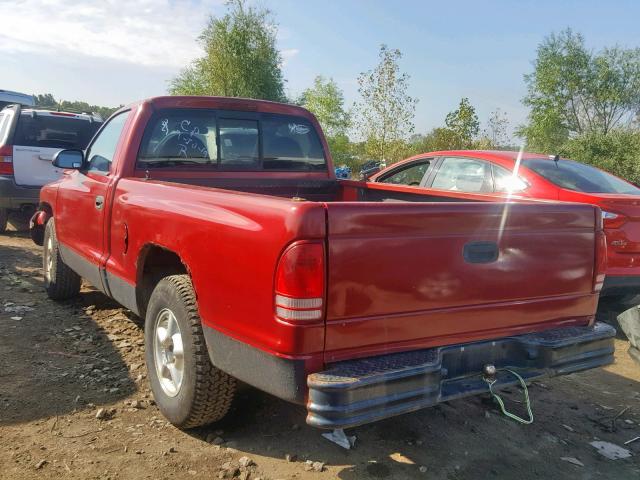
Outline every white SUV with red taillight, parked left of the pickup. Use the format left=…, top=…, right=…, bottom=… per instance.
left=0, top=105, right=102, bottom=232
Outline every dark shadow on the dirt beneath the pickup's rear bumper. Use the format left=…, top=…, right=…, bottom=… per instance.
left=191, top=345, right=640, bottom=480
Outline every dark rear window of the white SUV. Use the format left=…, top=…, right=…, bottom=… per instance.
left=13, top=113, right=102, bottom=150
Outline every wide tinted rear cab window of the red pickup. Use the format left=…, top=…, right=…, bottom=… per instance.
left=136, top=109, right=327, bottom=171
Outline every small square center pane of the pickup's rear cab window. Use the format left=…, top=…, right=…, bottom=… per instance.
left=218, top=118, right=260, bottom=168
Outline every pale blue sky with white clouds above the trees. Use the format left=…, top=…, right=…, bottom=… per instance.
left=0, top=0, right=640, bottom=133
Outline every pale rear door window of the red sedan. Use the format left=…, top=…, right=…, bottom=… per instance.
left=431, top=157, right=493, bottom=193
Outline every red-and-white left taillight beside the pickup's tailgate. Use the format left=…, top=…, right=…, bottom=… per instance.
left=274, top=242, right=324, bottom=322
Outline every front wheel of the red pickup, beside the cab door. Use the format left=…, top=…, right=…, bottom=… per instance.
left=42, top=218, right=82, bottom=300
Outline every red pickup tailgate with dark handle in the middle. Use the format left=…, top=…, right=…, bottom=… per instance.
left=326, top=203, right=597, bottom=361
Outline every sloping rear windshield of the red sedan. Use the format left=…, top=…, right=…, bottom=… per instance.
left=522, top=158, right=640, bottom=195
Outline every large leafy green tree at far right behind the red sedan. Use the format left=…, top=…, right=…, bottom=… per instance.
left=518, top=29, right=640, bottom=151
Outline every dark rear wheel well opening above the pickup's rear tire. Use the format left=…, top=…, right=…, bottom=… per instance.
left=136, top=245, right=188, bottom=317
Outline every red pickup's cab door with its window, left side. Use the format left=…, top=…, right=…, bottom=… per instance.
left=55, top=111, right=129, bottom=290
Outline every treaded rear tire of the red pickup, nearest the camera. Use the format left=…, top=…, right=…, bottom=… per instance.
left=145, top=275, right=236, bottom=429
